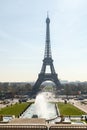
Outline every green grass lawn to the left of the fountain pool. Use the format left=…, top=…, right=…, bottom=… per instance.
left=0, top=102, right=30, bottom=117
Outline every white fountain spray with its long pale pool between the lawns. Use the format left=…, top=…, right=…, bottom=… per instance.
left=20, top=92, right=57, bottom=120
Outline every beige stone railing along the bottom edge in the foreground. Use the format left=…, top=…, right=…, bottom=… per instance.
left=0, top=124, right=87, bottom=130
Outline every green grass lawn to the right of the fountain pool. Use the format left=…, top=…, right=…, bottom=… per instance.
left=58, top=102, right=86, bottom=115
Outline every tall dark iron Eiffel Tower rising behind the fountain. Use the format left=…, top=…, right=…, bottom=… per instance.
left=32, top=15, right=60, bottom=94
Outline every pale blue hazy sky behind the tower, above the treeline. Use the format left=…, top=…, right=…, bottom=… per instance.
left=0, top=0, right=87, bottom=82
